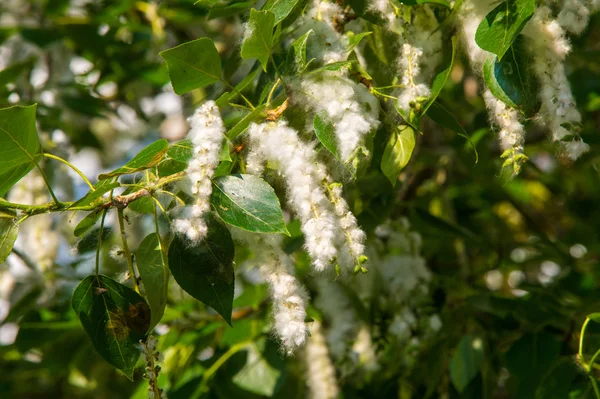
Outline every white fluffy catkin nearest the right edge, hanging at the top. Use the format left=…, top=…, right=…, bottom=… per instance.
left=523, top=6, right=589, bottom=160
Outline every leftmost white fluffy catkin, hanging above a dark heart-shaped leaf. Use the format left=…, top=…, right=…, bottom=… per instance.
left=173, top=101, right=225, bottom=242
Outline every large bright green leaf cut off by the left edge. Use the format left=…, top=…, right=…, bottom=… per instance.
left=0, top=104, right=41, bottom=185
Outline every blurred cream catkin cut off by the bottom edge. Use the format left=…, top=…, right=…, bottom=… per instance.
left=304, top=321, right=340, bottom=399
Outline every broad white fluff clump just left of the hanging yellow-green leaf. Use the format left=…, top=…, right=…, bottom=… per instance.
left=294, top=76, right=379, bottom=162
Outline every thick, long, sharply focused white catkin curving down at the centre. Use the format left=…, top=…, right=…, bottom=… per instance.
left=248, top=121, right=340, bottom=272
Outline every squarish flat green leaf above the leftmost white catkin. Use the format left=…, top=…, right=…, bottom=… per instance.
left=160, top=37, right=221, bottom=95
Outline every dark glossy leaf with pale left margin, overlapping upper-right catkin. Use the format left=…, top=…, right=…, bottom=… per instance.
left=483, top=39, right=539, bottom=115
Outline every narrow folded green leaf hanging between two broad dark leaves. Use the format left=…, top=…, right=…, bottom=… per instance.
left=136, top=233, right=169, bottom=330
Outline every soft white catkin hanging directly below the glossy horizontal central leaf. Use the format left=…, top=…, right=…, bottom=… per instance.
left=231, top=228, right=308, bottom=355
